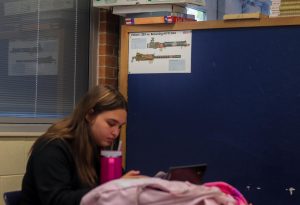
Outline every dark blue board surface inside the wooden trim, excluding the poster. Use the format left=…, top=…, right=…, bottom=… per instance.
left=121, top=19, right=300, bottom=205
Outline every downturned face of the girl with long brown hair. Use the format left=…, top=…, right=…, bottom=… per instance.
left=89, top=109, right=127, bottom=147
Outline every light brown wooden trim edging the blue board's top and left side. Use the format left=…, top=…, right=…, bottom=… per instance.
left=119, top=17, right=300, bottom=167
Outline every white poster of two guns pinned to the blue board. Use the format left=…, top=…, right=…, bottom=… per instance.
left=128, top=30, right=192, bottom=74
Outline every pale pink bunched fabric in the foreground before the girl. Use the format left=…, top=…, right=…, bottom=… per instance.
left=80, top=178, right=236, bottom=205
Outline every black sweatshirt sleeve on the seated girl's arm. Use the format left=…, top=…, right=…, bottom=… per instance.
left=31, top=140, right=90, bottom=205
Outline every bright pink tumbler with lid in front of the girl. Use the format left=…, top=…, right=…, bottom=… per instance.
left=100, top=150, right=122, bottom=184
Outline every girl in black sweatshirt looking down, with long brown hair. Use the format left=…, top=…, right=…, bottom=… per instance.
left=21, top=86, right=139, bottom=205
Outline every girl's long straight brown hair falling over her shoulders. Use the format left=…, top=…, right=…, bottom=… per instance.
left=31, top=86, right=127, bottom=187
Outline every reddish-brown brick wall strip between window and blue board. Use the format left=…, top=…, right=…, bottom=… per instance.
left=98, top=9, right=120, bottom=87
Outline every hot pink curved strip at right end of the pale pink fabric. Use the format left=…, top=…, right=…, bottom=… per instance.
left=204, top=182, right=248, bottom=205
